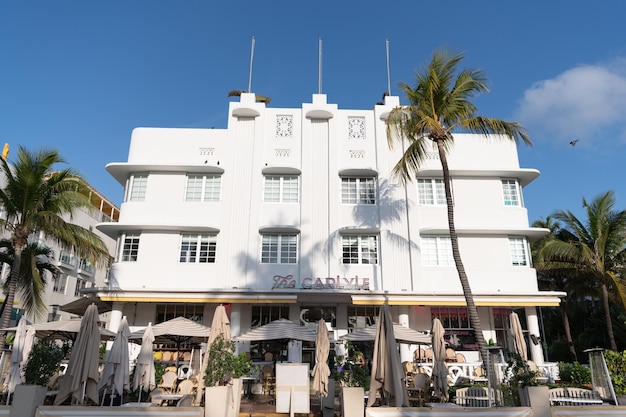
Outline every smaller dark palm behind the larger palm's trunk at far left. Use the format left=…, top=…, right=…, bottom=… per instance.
left=0, top=239, right=59, bottom=318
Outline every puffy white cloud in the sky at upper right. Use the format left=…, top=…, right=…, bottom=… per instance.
left=516, top=60, right=626, bottom=143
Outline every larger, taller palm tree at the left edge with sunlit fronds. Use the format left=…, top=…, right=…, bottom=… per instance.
left=0, top=146, right=109, bottom=349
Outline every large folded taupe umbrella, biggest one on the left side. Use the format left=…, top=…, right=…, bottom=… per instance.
left=54, top=304, right=100, bottom=405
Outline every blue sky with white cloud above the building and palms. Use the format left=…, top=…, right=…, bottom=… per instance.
left=0, top=0, right=626, bottom=221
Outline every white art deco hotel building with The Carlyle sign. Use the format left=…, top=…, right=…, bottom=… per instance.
left=97, top=93, right=562, bottom=370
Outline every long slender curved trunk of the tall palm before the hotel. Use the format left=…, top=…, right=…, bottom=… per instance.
left=437, top=139, right=489, bottom=366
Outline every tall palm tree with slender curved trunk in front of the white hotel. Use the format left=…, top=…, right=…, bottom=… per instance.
left=387, top=51, right=531, bottom=363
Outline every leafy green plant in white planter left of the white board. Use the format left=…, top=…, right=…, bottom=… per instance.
left=204, top=335, right=252, bottom=417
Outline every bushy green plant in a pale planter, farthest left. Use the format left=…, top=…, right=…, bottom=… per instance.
left=11, top=338, right=67, bottom=416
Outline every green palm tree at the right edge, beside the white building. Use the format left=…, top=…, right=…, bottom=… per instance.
left=536, top=191, right=626, bottom=351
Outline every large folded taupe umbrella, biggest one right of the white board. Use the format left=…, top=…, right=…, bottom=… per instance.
left=367, top=304, right=409, bottom=407
